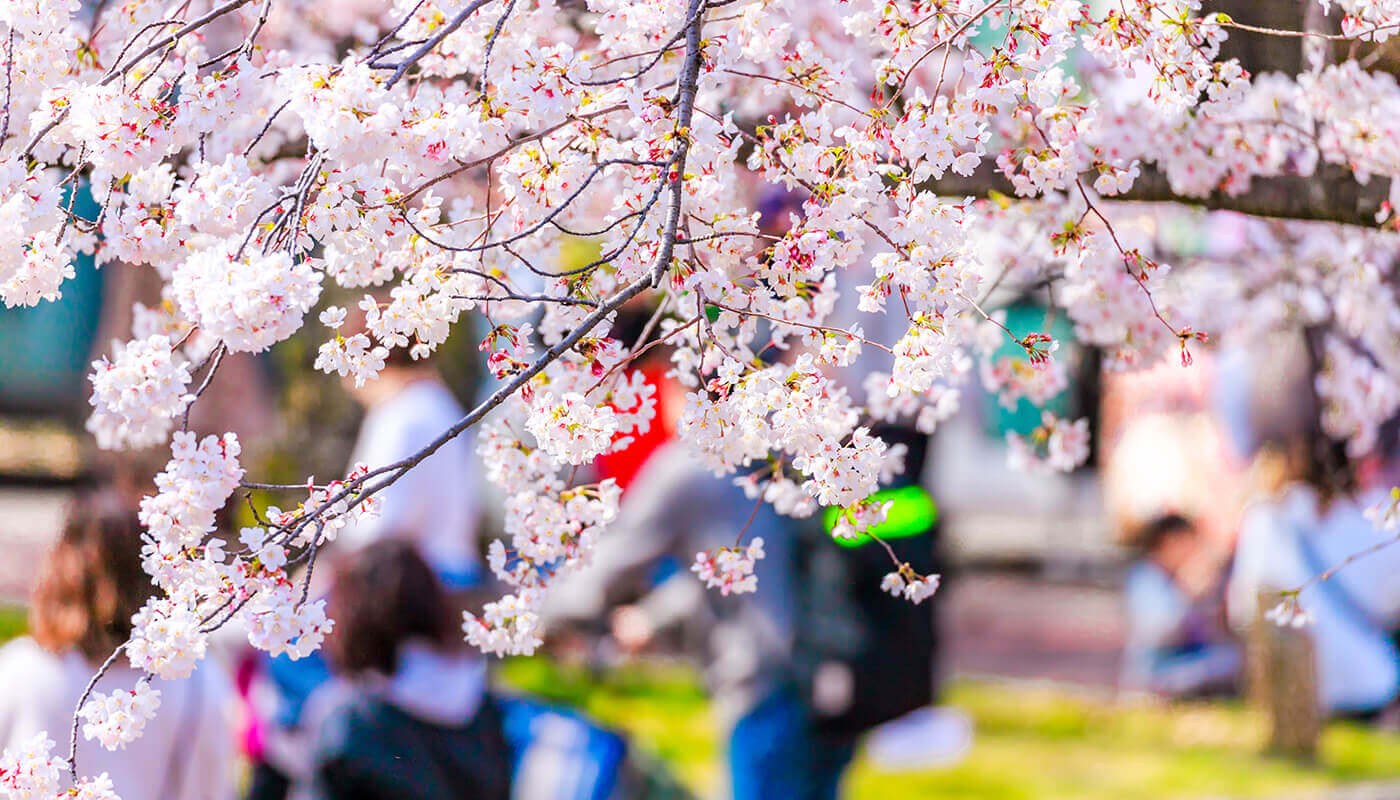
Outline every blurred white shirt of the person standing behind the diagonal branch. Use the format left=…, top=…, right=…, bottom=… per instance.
left=339, top=380, right=480, bottom=574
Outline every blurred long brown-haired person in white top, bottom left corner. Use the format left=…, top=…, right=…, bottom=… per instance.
left=0, top=493, right=234, bottom=800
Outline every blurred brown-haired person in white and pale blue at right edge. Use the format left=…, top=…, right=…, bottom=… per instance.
left=1228, top=432, right=1400, bottom=719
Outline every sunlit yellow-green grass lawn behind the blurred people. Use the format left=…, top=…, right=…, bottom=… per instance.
left=504, top=658, right=1400, bottom=800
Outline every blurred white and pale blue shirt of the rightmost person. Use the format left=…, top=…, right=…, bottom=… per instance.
left=1226, top=486, right=1400, bottom=710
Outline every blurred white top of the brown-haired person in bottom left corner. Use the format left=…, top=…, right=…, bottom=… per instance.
left=0, top=636, right=235, bottom=800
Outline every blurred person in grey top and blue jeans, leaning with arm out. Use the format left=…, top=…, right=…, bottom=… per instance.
left=545, top=441, right=855, bottom=800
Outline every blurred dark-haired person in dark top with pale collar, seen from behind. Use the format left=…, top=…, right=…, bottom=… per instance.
left=297, top=538, right=511, bottom=800
